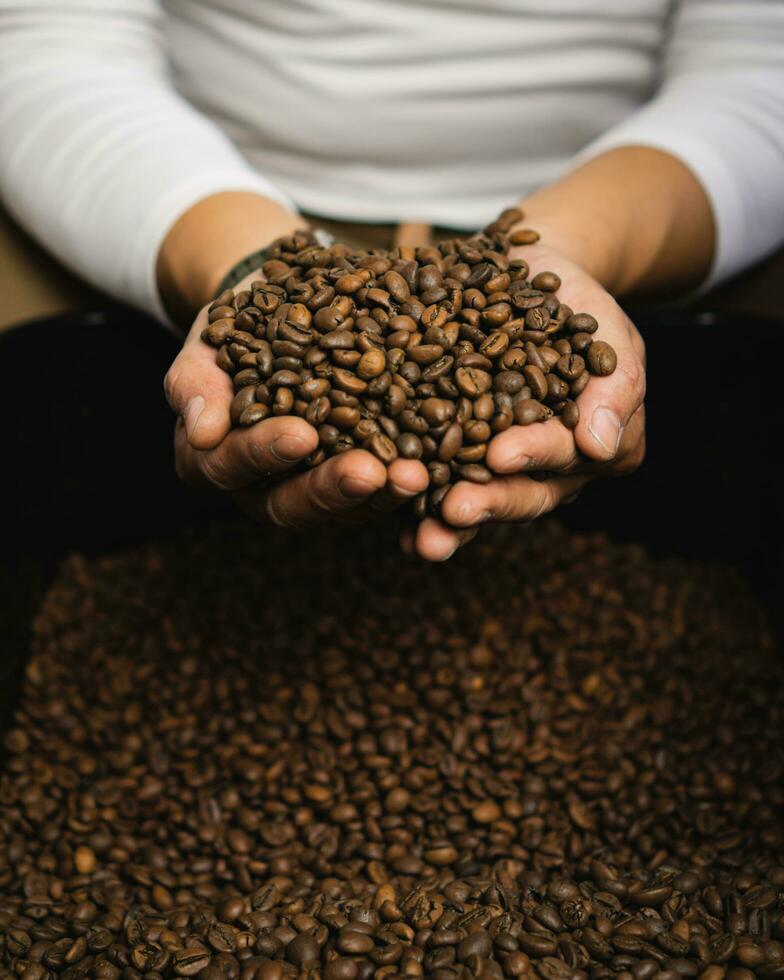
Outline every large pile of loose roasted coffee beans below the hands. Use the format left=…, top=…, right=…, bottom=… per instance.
left=0, top=523, right=784, bottom=980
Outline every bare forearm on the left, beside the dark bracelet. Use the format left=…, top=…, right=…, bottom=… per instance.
left=156, top=191, right=307, bottom=323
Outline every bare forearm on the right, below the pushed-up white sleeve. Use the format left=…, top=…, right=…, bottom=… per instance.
left=521, top=146, right=715, bottom=296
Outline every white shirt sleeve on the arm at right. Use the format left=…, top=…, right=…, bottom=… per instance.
left=580, top=0, right=784, bottom=290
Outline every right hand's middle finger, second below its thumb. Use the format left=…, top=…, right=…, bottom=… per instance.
left=441, top=474, right=588, bottom=528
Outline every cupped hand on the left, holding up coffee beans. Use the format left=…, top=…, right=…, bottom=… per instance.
left=164, top=272, right=428, bottom=528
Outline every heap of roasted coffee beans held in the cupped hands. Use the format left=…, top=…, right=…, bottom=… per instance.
left=202, top=208, right=616, bottom=517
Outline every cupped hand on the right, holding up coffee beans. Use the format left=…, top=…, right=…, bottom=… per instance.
left=402, top=245, right=645, bottom=561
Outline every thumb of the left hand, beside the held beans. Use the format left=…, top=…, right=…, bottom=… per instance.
left=163, top=310, right=234, bottom=449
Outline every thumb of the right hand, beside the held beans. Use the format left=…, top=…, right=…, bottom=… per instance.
left=574, top=307, right=645, bottom=462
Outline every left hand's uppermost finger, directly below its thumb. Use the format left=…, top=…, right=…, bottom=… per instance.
left=175, top=415, right=318, bottom=490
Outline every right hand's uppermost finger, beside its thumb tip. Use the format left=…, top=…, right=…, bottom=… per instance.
left=487, top=419, right=580, bottom=473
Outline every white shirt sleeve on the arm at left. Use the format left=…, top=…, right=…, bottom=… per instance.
left=0, top=0, right=294, bottom=319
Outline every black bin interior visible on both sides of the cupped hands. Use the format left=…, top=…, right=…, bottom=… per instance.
left=0, top=308, right=784, bottom=727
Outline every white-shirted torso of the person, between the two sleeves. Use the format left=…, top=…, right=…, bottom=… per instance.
left=164, top=0, right=673, bottom=228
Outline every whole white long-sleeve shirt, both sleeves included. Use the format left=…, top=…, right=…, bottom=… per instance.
left=0, top=0, right=784, bottom=315
